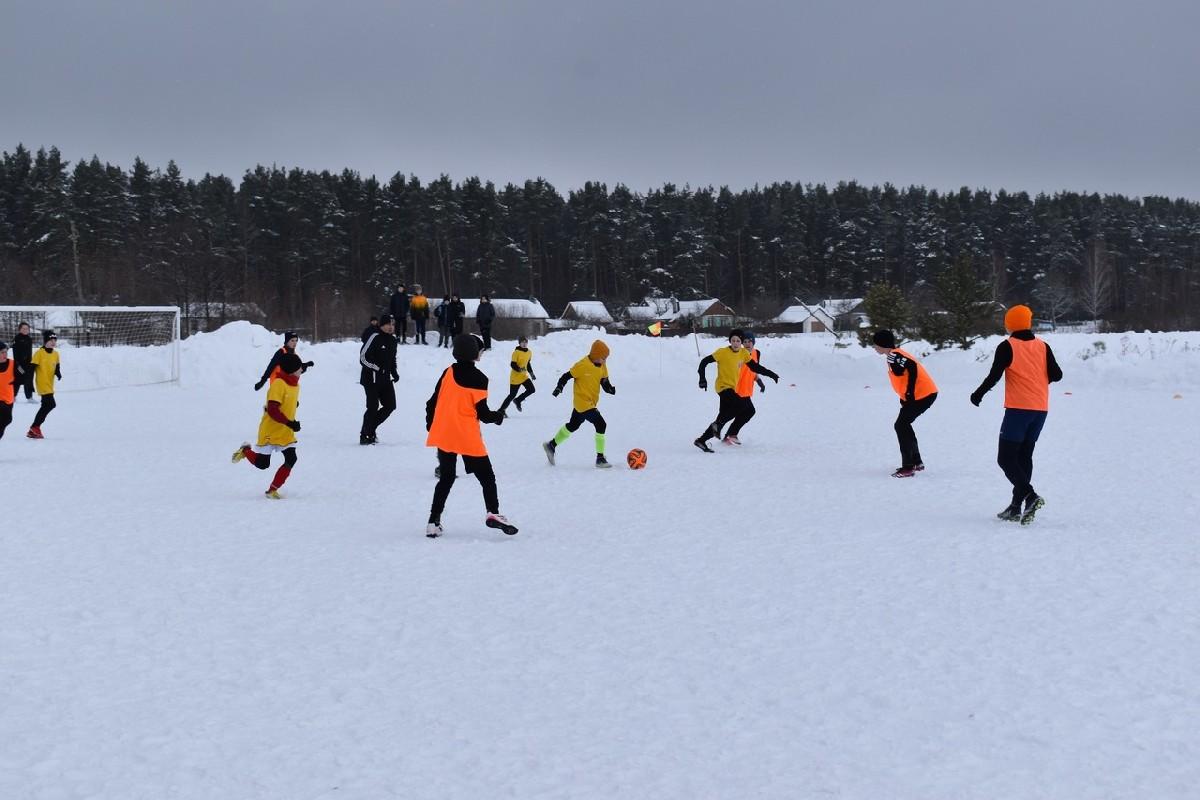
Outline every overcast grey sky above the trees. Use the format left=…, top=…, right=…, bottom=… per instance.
left=0, top=0, right=1200, bottom=199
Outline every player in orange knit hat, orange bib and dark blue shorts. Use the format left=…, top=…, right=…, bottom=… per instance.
left=971, top=306, right=1062, bottom=525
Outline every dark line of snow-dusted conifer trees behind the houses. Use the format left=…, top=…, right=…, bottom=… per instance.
left=0, top=145, right=1200, bottom=337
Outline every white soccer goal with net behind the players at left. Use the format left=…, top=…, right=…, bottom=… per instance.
left=0, top=306, right=180, bottom=392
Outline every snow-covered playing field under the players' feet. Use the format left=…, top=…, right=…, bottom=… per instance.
left=0, top=324, right=1200, bottom=800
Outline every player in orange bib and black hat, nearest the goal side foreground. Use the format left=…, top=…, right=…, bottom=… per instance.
left=425, top=333, right=517, bottom=539
